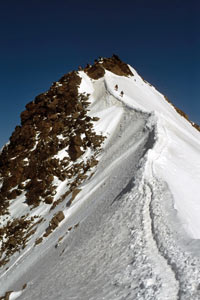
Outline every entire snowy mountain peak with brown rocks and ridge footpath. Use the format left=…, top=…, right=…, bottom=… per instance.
left=0, top=55, right=200, bottom=300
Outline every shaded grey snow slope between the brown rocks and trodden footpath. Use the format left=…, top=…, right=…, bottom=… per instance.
left=0, top=105, right=178, bottom=300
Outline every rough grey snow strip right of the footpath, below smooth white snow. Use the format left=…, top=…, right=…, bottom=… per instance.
left=150, top=180, right=200, bottom=300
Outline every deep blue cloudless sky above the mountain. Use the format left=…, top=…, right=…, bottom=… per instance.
left=0, top=0, right=200, bottom=147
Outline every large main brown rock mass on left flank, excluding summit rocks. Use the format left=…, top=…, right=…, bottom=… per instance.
left=0, top=67, right=104, bottom=214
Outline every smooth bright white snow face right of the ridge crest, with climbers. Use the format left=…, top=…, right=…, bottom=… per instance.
left=105, top=68, right=200, bottom=239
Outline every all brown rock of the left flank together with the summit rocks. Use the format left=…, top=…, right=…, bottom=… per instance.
left=0, top=55, right=136, bottom=267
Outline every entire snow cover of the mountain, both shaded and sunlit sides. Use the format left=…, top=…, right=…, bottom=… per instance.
left=0, top=68, right=200, bottom=300
